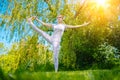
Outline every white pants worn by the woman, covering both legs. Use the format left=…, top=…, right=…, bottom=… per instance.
left=30, top=23, right=60, bottom=72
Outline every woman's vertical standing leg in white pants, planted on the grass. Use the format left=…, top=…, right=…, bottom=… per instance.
left=53, top=42, right=60, bottom=72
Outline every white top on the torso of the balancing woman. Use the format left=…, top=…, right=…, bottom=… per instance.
left=52, top=24, right=66, bottom=42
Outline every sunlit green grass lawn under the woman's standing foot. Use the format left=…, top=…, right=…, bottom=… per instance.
left=2, top=70, right=120, bottom=80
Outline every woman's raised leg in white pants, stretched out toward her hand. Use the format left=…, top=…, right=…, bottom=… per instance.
left=29, top=22, right=52, bottom=43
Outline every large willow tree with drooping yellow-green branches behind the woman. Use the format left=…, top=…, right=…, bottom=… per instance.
left=1, top=0, right=120, bottom=69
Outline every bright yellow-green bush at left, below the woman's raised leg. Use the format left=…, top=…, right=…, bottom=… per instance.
left=0, top=36, right=53, bottom=73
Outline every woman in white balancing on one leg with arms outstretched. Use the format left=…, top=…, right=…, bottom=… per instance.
left=28, top=15, right=89, bottom=72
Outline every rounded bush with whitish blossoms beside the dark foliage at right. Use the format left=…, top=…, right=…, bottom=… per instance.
left=93, top=43, right=120, bottom=69
